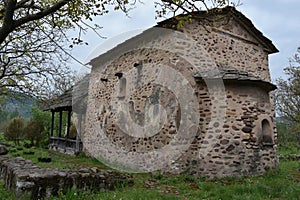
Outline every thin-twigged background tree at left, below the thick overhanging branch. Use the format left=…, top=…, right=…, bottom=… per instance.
left=0, top=25, right=72, bottom=96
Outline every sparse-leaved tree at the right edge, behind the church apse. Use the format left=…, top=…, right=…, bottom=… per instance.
left=275, top=48, right=300, bottom=142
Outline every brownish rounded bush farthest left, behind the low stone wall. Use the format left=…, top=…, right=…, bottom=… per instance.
left=4, top=117, right=24, bottom=145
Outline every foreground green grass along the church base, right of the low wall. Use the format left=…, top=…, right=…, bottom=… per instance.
left=48, top=161, right=300, bottom=200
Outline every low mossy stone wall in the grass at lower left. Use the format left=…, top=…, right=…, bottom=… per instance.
left=0, top=156, right=133, bottom=199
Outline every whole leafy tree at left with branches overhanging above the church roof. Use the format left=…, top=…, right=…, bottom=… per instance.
left=0, top=0, right=236, bottom=97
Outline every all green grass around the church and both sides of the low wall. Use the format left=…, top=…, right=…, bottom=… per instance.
left=0, top=140, right=300, bottom=200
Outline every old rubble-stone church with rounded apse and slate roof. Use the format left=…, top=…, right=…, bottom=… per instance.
left=82, top=7, right=278, bottom=177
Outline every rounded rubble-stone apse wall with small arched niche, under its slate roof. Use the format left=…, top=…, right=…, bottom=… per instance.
left=171, top=83, right=279, bottom=177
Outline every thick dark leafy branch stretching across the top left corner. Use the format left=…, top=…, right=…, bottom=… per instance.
left=0, top=0, right=129, bottom=43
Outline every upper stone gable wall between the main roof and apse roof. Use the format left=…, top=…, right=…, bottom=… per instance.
left=176, top=14, right=271, bottom=82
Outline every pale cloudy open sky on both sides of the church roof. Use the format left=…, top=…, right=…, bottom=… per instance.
left=71, top=0, right=300, bottom=82
